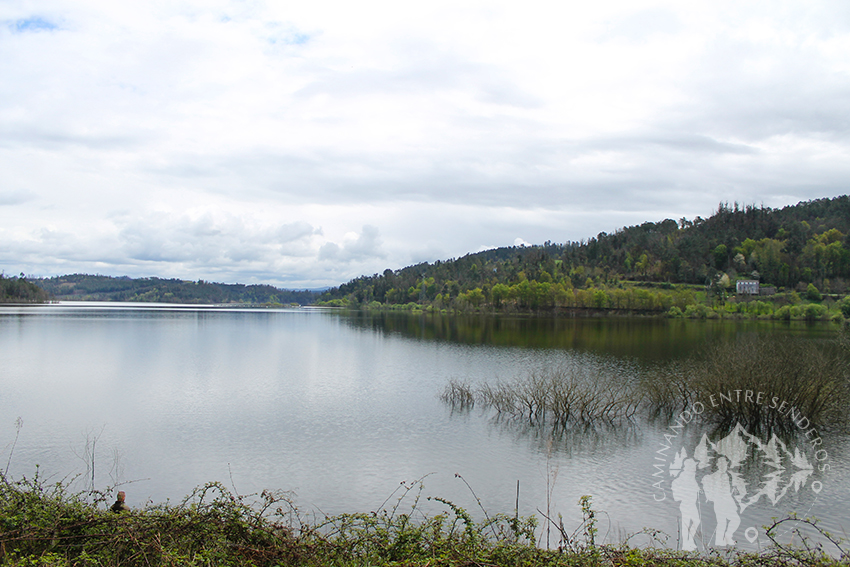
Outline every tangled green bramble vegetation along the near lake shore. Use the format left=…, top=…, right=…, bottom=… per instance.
left=0, top=472, right=850, bottom=567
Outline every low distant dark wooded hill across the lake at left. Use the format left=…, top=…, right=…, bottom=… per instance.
left=31, top=274, right=319, bottom=305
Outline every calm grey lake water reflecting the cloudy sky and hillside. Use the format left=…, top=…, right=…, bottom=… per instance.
left=0, top=303, right=850, bottom=547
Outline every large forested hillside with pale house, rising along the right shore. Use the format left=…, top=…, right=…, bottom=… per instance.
left=321, top=196, right=850, bottom=316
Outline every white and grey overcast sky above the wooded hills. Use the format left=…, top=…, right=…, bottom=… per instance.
left=0, top=0, right=850, bottom=288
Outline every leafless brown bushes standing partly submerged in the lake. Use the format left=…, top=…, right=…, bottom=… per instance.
left=442, top=336, right=850, bottom=438
